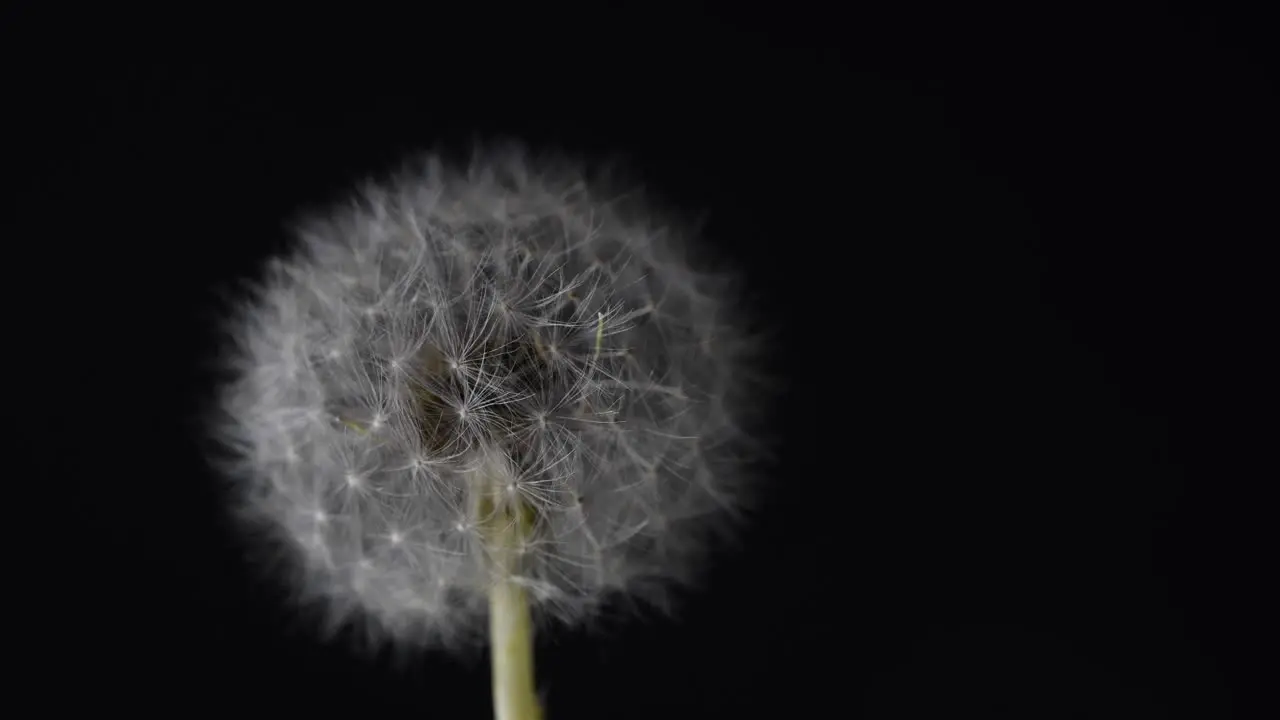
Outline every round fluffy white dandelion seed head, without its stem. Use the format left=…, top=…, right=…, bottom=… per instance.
left=216, top=146, right=763, bottom=643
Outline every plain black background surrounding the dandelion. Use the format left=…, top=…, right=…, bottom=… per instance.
left=15, top=3, right=1277, bottom=720
